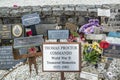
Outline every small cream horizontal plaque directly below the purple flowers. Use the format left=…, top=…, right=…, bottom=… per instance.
left=86, top=34, right=106, bottom=40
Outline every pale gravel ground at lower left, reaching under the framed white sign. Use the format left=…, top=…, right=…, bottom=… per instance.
left=0, top=57, right=79, bottom=80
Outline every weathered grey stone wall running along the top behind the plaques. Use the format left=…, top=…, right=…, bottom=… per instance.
left=0, top=4, right=120, bottom=25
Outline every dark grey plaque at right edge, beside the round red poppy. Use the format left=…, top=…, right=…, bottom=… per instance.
left=103, top=44, right=120, bottom=58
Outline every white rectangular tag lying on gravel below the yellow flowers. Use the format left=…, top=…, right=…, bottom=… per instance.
left=80, top=71, right=98, bottom=80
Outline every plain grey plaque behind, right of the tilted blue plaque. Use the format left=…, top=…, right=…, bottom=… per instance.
left=35, top=24, right=57, bottom=36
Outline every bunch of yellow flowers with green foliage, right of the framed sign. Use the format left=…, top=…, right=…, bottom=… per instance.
left=83, top=42, right=102, bottom=64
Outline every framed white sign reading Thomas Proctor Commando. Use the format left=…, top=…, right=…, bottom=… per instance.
left=43, top=42, right=81, bottom=72
